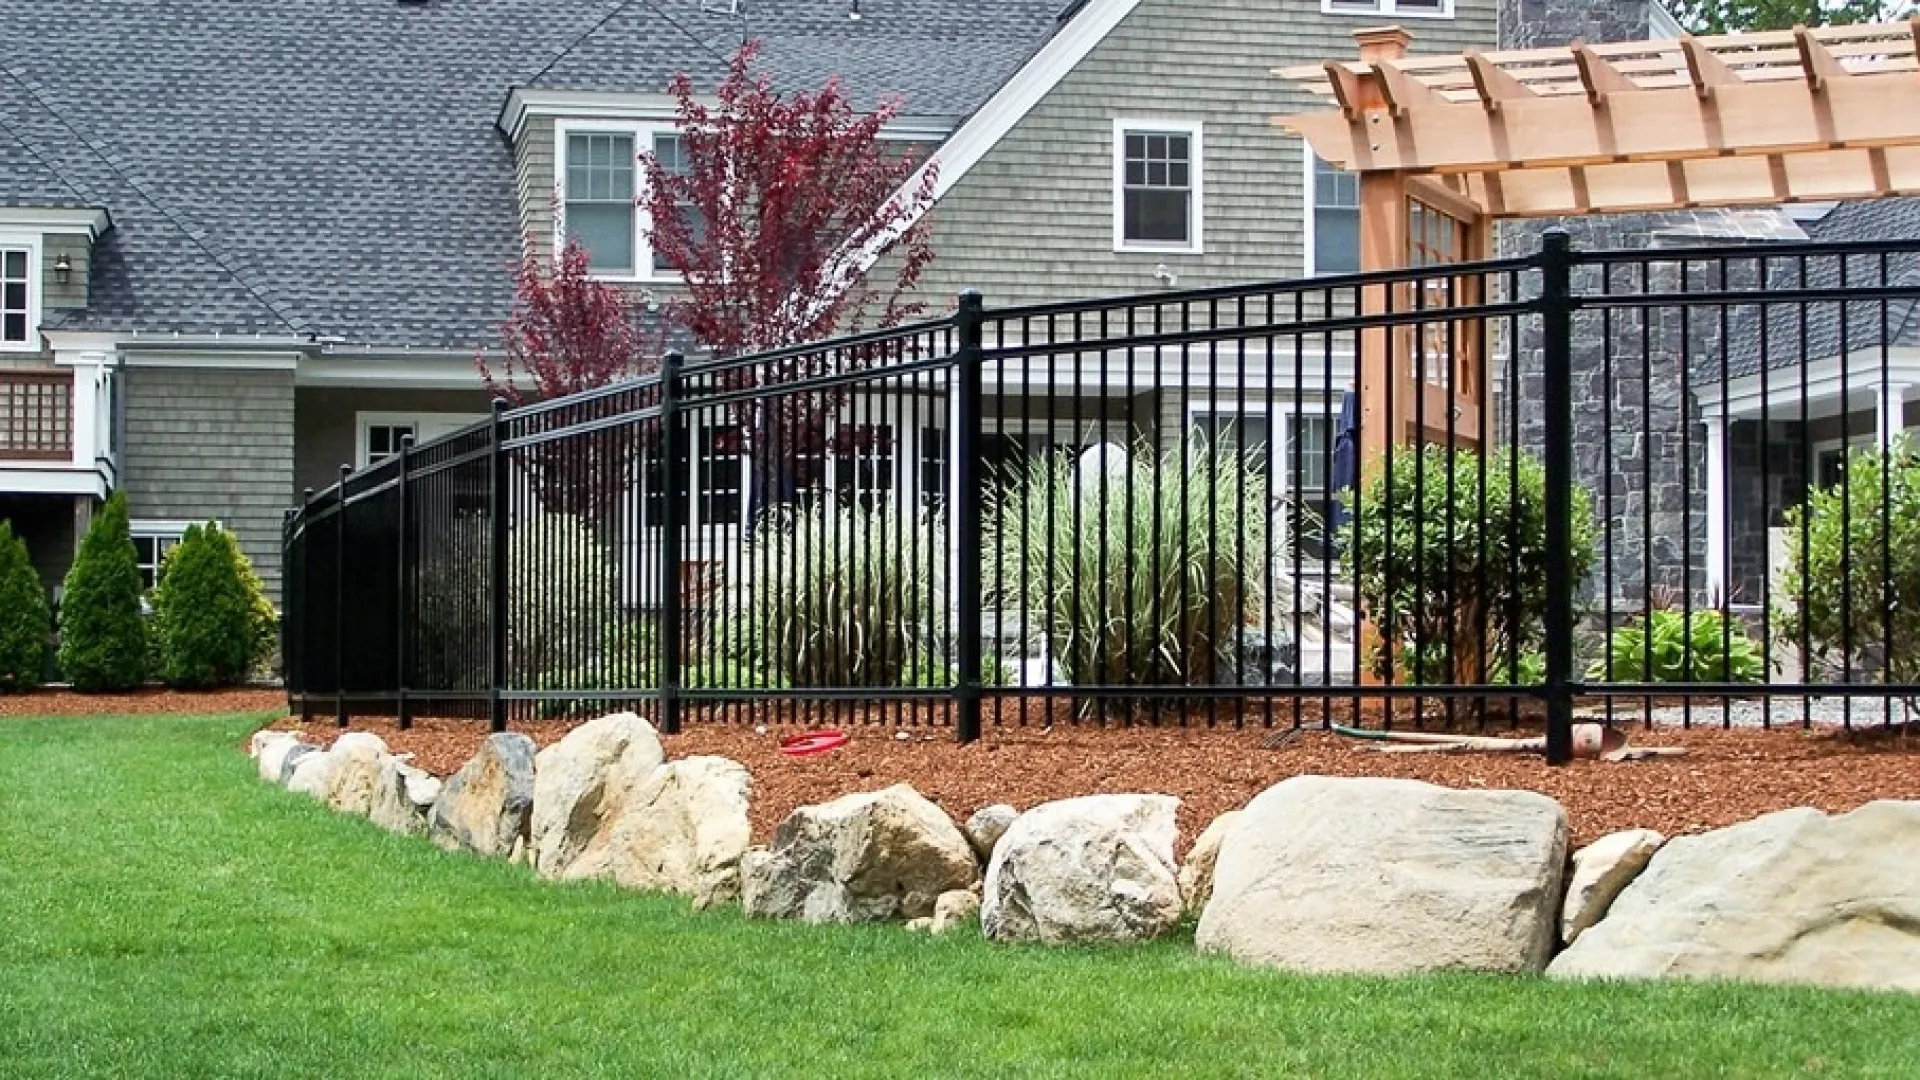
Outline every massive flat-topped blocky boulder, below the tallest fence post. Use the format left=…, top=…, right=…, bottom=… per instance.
left=1194, top=776, right=1567, bottom=974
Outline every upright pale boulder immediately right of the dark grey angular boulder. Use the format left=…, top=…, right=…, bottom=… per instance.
left=528, top=713, right=666, bottom=878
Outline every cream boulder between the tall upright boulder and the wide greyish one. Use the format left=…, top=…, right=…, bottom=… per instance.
left=606, top=757, right=753, bottom=909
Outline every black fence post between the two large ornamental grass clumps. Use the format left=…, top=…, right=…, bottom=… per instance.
left=952, top=288, right=985, bottom=742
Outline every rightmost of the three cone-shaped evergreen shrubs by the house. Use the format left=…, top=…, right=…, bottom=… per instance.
left=152, top=523, right=271, bottom=690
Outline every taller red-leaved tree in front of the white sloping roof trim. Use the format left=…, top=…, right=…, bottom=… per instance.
left=641, top=42, right=935, bottom=511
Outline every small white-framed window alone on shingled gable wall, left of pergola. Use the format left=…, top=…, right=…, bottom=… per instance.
left=1114, top=119, right=1206, bottom=256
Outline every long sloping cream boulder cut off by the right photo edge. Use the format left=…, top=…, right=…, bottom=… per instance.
left=1548, top=801, right=1920, bottom=992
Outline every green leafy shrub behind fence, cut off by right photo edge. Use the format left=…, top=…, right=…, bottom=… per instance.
left=1774, top=438, right=1920, bottom=682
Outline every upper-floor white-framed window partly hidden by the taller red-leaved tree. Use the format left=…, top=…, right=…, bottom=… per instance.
left=553, top=121, right=699, bottom=281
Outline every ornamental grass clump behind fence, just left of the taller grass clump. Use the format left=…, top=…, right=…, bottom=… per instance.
left=729, top=500, right=947, bottom=686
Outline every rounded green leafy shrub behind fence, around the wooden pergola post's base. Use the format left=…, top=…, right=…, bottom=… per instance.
left=1354, top=446, right=1594, bottom=684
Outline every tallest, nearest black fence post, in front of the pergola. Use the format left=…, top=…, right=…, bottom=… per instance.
left=1540, top=229, right=1578, bottom=765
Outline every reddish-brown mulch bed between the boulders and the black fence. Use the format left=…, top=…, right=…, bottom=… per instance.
left=276, top=719, right=1920, bottom=844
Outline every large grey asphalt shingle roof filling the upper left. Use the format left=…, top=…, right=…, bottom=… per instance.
left=0, top=0, right=1058, bottom=348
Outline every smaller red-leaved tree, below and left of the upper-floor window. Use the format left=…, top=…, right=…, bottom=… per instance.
left=474, top=240, right=659, bottom=525
